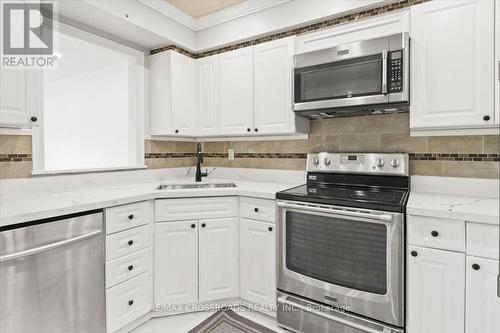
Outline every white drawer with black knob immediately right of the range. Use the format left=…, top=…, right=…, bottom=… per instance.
left=408, top=216, right=465, bottom=252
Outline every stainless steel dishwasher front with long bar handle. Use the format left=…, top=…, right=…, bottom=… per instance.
left=0, top=212, right=106, bottom=333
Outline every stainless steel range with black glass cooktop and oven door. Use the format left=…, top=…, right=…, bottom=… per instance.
left=276, top=153, right=409, bottom=333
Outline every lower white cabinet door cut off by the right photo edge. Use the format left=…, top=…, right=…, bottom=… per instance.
left=465, top=256, right=500, bottom=333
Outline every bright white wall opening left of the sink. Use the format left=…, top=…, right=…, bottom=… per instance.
left=33, top=23, right=144, bottom=174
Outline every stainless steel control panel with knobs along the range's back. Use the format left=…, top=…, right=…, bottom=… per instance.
left=307, top=152, right=409, bottom=176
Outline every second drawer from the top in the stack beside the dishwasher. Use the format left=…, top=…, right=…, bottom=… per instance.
left=106, top=225, right=151, bottom=261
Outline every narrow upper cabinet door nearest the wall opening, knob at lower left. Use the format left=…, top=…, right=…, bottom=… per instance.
left=171, top=52, right=196, bottom=136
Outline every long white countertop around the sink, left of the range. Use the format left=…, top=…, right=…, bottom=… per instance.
left=0, top=177, right=300, bottom=227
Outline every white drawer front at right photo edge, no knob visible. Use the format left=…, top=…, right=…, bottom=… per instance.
left=467, top=223, right=499, bottom=260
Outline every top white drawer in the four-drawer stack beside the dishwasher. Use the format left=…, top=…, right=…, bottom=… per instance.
left=106, top=201, right=153, bottom=235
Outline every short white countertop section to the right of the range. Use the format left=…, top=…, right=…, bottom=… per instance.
left=407, top=177, right=500, bottom=225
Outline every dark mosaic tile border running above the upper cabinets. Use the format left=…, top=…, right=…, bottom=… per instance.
left=151, top=0, right=430, bottom=59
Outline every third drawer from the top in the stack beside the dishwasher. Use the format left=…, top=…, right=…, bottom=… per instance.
left=106, top=249, right=151, bottom=288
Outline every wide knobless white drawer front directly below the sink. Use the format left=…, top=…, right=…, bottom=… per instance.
left=155, top=197, right=238, bottom=222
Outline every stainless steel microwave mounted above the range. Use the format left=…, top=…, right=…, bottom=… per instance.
left=294, top=33, right=410, bottom=118
